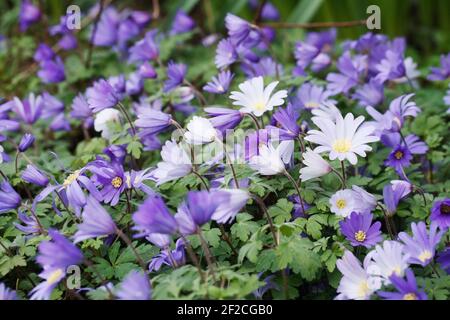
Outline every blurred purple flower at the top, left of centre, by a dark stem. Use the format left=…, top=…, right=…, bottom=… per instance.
left=90, top=6, right=120, bottom=47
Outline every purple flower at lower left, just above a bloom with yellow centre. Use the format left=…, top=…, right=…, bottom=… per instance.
left=36, top=229, right=83, bottom=272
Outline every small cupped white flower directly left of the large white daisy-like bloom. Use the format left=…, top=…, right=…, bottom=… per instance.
left=249, top=144, right=285, bottom=176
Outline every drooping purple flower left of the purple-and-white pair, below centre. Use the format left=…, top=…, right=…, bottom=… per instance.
left=133, top=195, right=177, bottom=237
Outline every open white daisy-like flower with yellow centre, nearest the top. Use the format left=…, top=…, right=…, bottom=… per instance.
left=230, top=77, right=287, bottom=117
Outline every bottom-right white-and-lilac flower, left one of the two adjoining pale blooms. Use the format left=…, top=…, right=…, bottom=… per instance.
left=336, top=251, right=381, bottom=300
